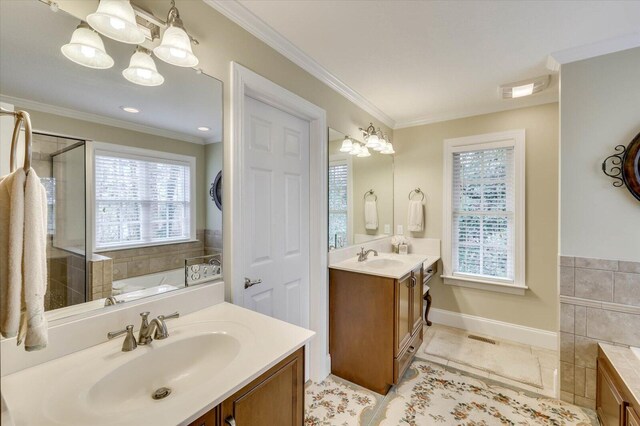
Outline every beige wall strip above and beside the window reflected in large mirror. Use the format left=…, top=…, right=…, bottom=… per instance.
left=16, top=105, right=208, bottom=229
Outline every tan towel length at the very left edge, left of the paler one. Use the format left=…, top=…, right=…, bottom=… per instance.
left=0, top=168, right=26, bottom=337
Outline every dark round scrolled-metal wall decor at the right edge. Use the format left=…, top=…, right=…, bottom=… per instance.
left=602, top=133, right=640, bottom=201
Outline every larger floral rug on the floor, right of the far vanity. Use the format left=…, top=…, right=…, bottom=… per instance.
left=376, top=361, right=597, bottom=426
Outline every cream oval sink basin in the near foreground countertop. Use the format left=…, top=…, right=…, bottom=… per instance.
left=87, top=332, right=241, bottom=411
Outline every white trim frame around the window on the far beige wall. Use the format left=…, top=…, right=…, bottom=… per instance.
left=442, top=129, right=528, bottom=294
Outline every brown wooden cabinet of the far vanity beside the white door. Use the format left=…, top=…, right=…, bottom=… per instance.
left=329, top=265, right=423, bottom=395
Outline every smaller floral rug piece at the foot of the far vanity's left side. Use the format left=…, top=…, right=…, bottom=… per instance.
left=304, top=376, right=382, bottom=426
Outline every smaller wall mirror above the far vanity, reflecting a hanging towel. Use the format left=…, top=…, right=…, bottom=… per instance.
left=329, top=128, right=393, bottom=250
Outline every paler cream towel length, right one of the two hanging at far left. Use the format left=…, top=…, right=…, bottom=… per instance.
left=18, top=169, right=48, bottom=351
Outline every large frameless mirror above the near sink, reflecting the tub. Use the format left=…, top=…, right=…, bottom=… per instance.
left=0, top=0, right=223, bottom=319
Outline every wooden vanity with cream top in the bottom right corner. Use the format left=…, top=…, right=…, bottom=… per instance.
left=596, top=343, right=640, bottom=426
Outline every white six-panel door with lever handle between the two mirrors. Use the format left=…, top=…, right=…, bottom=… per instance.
left=242, top=97, right=309, bottom=327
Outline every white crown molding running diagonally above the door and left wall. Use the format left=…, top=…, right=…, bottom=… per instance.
left=204, top=0, right=396, bottom=129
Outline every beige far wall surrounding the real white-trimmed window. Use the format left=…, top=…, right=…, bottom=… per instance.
left=394, top=103, right=558, bottom=331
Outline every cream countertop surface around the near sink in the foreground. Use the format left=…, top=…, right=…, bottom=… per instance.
left=1, top=303, right=315, bottom=426
